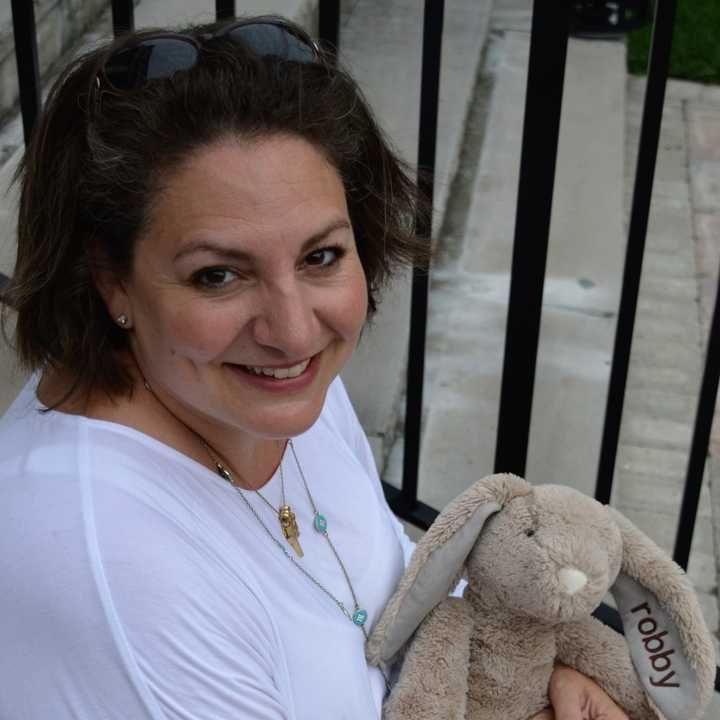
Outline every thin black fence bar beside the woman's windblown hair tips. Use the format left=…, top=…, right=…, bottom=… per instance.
left=393, top=0, right=445, bottom=513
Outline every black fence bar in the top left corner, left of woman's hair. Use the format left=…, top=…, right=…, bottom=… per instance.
left=12, top=0, right=41, bottom=145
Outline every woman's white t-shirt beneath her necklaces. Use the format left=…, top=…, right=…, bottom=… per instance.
left=0, top=378, right=412, bottom=720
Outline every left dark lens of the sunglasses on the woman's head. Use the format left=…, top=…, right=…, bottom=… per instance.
left=104, top=38, right=198, bottom=90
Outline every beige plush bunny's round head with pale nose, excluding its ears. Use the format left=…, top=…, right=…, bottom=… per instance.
left=466, top=478, right=623, bottom=624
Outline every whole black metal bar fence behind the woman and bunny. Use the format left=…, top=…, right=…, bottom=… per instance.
left=5, top=0, right=720, bottom=691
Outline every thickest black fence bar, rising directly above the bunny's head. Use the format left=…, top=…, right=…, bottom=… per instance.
left=495, top=0, right=571, bottom=475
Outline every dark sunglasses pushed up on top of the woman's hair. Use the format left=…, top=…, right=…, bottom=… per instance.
left=95, top=16, right=321, bottom=91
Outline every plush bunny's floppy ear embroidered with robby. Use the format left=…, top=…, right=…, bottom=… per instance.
left=609, top=508, right=715, bottom=720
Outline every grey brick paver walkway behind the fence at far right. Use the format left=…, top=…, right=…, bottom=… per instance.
left=613, top=78, right=720, bottom=652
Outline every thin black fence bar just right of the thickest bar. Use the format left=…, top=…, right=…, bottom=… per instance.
left=595, top=0, right=677, bottom=503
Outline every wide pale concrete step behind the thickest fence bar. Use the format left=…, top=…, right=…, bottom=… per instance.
left=395, top=11, right=625, bottom=508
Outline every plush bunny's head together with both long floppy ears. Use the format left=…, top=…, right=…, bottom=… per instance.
left=367, top=474, right=715, bottom=718
